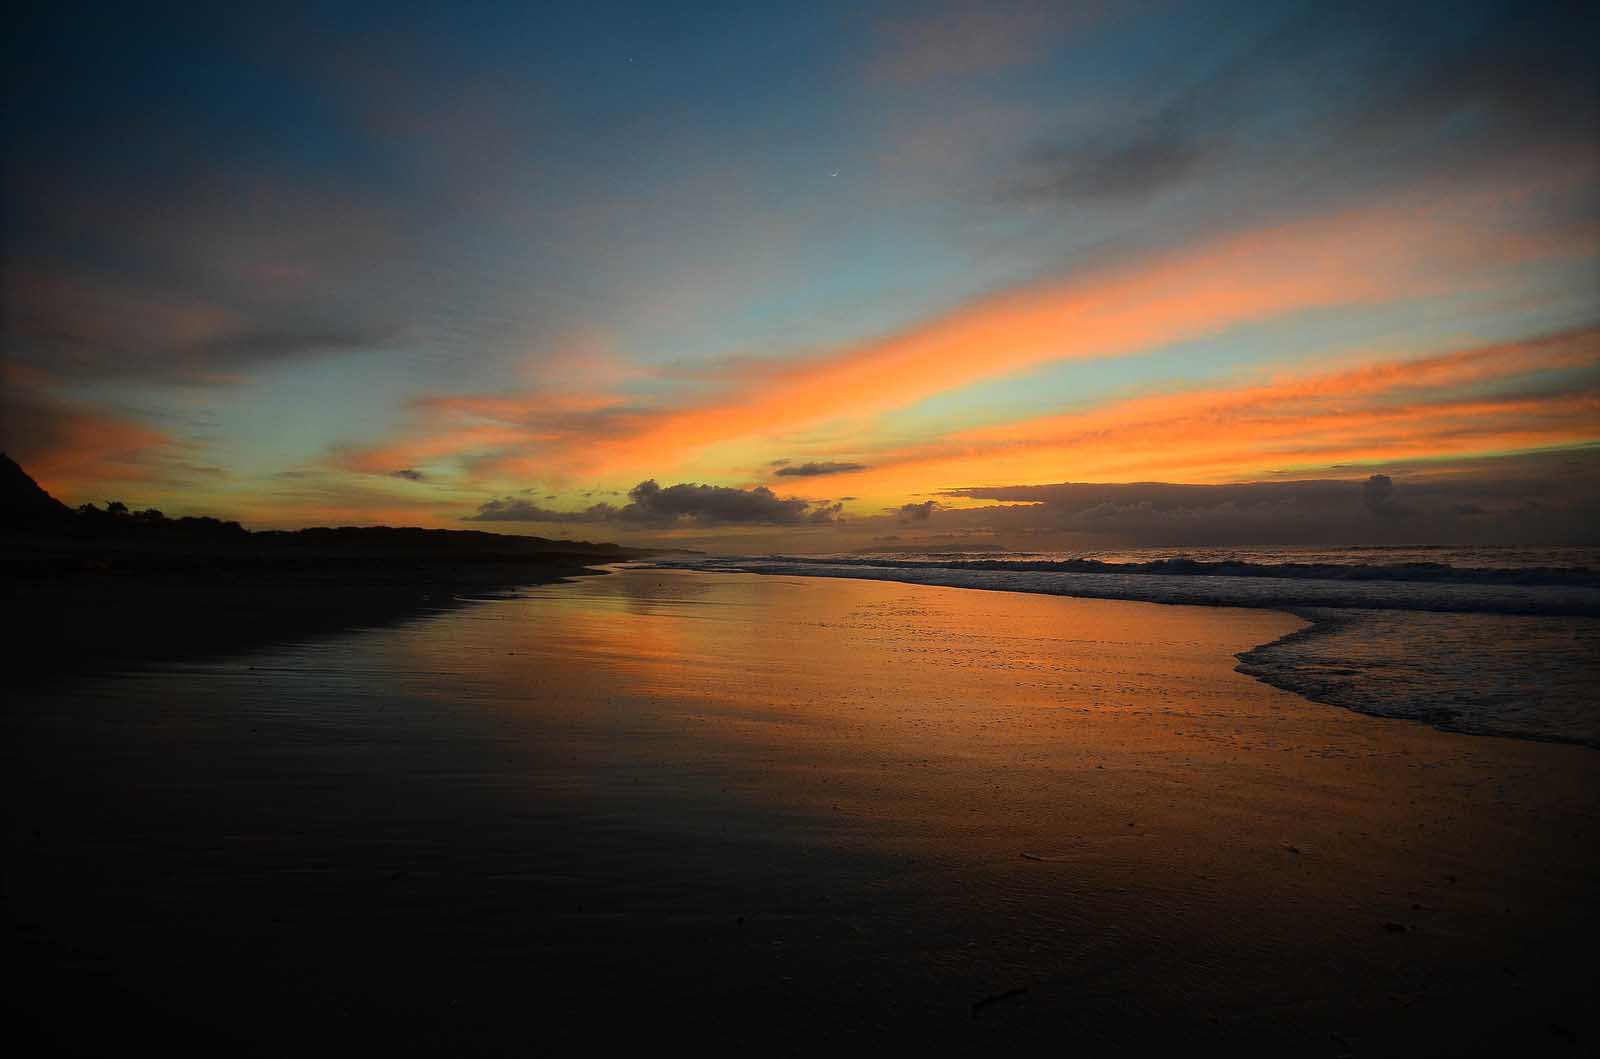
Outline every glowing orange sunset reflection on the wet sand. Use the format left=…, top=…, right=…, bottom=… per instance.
left=390, top=569, right=1587, bottom=936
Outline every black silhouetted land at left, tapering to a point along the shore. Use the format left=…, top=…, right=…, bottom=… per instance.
left=0, top=454, right=643, bottom=685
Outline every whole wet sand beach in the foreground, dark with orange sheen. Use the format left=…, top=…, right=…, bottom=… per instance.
left=0, top=569, right=1600, bottom=1056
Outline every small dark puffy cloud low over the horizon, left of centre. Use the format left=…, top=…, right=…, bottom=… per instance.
left=467, top=478, right=843, bottom=528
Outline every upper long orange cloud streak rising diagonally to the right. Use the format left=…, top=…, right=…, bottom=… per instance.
left=331, top=183, right=1587, bottom=499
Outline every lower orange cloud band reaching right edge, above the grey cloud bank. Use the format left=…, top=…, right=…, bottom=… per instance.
left=812, top=328, right=1600, bottom=494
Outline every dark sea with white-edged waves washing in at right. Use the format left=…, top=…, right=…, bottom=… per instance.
left=658, top=545, right=1600, bottom=747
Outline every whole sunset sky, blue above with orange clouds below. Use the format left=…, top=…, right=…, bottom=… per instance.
left=0, top=0, right=1600, bottom=552
